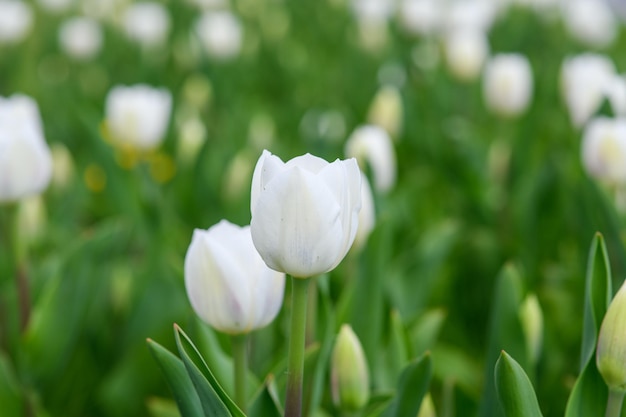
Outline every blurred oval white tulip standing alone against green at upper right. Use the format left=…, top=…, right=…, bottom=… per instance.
left=483, top=53, right=533, bottom=116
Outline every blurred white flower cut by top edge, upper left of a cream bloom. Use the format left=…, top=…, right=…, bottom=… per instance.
left=398, top=0, right=443, bottom=36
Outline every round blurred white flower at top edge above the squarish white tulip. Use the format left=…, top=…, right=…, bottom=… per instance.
left=123, top=2, right=170, bottom=48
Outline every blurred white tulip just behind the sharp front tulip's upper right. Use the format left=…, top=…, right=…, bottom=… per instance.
left=345, top=125, right=397, bottom=193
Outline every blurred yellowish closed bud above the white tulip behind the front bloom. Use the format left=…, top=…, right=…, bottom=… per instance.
left=367, top=86, right=403, bottom=138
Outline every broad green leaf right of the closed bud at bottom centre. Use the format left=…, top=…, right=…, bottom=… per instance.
left=383, top=353, right=432, bottom=417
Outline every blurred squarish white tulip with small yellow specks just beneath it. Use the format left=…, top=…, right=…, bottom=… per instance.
left=105, top=84, right=172, bottom=150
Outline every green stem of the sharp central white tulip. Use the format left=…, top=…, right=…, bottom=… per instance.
left=285, top=277, right=309, bottom=417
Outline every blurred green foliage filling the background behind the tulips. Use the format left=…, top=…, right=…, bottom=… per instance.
left=0, top=0, right=626, bottom=417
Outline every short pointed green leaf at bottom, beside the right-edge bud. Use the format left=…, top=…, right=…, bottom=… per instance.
left=565, top=354, right=609, bottom=417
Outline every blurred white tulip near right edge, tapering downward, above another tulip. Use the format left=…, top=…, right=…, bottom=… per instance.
left=561, top=53, right=615, bottom=127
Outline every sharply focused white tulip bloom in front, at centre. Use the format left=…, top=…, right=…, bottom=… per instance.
left=250, top=151, right=361, bottom=278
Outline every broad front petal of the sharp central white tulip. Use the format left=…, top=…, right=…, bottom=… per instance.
left=251, top=166, right=343, bottom=277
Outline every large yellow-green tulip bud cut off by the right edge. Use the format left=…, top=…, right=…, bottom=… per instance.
left=596, top=284, right=626, bottom=392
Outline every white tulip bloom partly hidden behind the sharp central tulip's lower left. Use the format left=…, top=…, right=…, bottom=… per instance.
left=185, top=220, right=285, bottom=334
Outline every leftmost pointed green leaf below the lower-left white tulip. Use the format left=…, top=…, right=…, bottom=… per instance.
left=148, top=339, right=204, bottom=417
